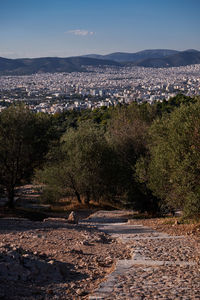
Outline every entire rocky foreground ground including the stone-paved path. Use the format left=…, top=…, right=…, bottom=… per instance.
left=0, top=211, right=200, bottom=300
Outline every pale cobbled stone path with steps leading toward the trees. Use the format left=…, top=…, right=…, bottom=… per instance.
left=80, top=211, right=200, bottom=300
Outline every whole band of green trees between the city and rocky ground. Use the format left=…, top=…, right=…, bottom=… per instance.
left=0, top=95, right=200, bottom=217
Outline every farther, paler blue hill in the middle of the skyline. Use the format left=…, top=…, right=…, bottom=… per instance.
left=83, top=49, right=179, bottom=62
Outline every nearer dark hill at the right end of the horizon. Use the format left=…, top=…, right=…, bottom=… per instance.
left=133, top=50, right=200, bottom=68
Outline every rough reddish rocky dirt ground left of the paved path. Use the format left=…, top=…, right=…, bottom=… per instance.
left=0, top=217, right=130, bottom=300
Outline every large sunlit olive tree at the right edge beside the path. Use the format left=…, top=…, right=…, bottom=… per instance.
left=143, top=102, right=200, bottom=216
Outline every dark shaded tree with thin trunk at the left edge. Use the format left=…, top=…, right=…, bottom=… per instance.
left=0, top=105, right=52, bottom=207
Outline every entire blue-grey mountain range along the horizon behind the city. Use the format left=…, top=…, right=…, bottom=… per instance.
left=0, top=49, right=200, bottom=75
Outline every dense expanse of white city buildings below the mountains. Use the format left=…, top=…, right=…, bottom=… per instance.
left=0, top=64, right=200, bottom=114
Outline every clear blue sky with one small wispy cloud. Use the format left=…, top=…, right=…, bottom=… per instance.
left=0, top=0, right=200, bottom=58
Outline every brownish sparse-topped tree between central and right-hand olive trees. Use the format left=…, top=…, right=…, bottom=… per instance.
left=108, top=104, right=157, bottom=212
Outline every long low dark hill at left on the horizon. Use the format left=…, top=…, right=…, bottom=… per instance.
left=0, top=56, right=120, bottom=75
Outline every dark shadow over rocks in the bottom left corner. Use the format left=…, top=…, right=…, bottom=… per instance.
left=0, top=246, right=88, bottom=299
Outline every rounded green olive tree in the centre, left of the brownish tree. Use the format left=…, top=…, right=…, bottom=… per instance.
left=36, top=122, right=117, bottom=203
